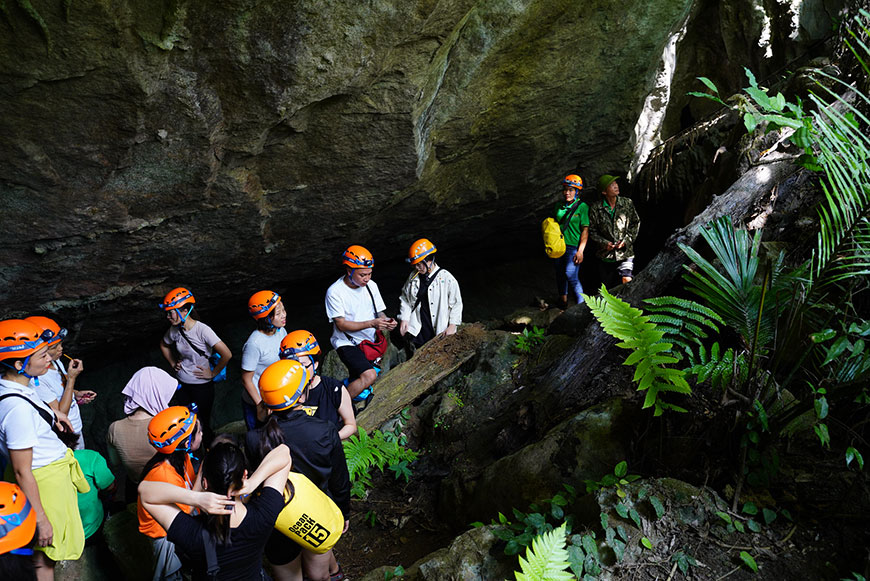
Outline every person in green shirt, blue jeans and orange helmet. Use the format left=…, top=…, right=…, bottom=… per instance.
left=553, top=174, right=589, bottom=309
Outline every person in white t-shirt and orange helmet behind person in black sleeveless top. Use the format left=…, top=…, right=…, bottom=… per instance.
left=242, top=290, right=287, bottom=430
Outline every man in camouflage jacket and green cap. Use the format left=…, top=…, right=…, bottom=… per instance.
left=589, top=174, right=640, bottom=288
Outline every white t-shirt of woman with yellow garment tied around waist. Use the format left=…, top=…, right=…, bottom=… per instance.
left=0, top=379, right=66, bottom=470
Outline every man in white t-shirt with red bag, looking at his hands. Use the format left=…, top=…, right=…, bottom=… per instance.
left=326, top=245, right=396, bottom=401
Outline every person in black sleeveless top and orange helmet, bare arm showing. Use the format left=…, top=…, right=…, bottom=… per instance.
left=280, top=329, right=357, bottom=441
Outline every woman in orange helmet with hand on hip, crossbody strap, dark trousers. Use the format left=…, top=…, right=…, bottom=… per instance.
left=159, top=287, right=233, bottom=440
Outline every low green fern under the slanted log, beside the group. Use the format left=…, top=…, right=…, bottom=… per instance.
left=344, top=428, right=418, bottom=498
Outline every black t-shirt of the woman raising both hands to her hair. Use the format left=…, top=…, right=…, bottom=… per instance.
left=166, top=488, right=284, bottom=581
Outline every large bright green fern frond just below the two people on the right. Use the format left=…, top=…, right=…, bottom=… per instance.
left=584, top=285, right=692, bottom=416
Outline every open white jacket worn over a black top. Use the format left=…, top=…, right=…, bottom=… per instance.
left=399, top=264, right=462, bottom=336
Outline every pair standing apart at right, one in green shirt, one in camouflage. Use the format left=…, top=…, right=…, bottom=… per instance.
left=552, top=174, right=640, bottom=308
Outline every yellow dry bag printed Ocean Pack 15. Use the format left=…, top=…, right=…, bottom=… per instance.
left=275, top=472, right=344, bottom=553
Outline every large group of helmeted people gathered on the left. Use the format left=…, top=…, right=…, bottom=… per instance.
left=0, top=239, right=462, bottom=581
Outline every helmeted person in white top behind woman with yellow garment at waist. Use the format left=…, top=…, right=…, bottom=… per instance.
left=24, top=316, right=97, bottom=450
